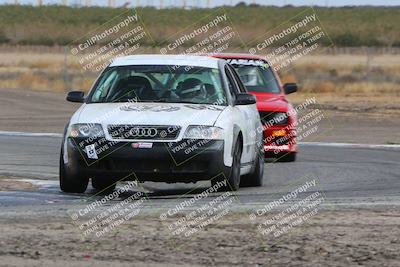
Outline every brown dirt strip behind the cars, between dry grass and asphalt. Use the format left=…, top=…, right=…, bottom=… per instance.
left=0, top=89, right=400, bottom=144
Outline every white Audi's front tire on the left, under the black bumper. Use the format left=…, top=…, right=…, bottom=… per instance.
left=59, top=150, right=89, bottom=193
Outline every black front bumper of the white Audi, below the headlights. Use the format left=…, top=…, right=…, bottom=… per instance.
left=66, top=137, right=227, bottom=182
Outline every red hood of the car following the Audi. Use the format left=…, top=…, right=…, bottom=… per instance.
left=250, top=92, right=289, bottom=112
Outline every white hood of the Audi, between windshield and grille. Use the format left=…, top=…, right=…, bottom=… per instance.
left=72, top=103, right=225, bottom=128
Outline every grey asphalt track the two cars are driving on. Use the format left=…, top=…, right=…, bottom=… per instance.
left=0, top=135, right=400, bottom=219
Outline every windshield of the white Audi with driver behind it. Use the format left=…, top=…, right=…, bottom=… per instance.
left=88, top=65, right=226, bottom=105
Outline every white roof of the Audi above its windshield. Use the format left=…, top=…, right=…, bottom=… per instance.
left=110, top=55, right=221, bottom=69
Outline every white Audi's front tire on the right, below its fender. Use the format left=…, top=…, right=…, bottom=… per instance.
left=211, top=141, right=242, bottom=191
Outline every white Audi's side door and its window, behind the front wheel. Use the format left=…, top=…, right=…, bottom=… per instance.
left=225, top=64, right=258, bottom=165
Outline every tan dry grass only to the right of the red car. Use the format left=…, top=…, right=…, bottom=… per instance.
left=281, top=54, right=400, bottom=99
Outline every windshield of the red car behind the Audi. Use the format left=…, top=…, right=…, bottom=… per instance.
left=231, top=61, right=280, bottom=94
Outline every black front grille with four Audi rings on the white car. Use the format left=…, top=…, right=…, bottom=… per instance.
left=107, top=124, right=181, bottom=140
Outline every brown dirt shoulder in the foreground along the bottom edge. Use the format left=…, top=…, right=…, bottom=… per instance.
left=0, top=209, right=400, bottom=266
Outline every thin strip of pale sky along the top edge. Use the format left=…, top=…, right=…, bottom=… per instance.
left=0, top=0, right=400, bottom=7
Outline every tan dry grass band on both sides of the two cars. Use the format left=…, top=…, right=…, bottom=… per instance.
left=0, top=52, right=400, bottom=100
